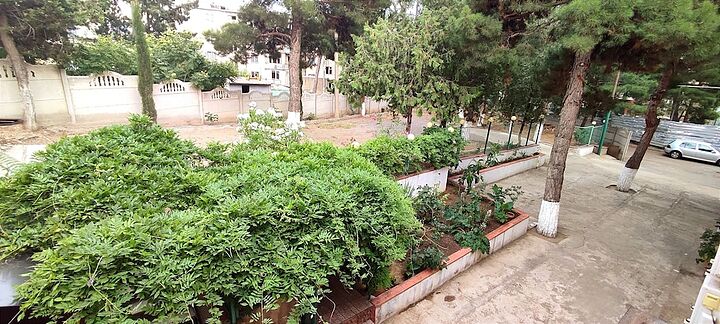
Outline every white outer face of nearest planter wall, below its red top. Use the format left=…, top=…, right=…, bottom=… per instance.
left=375, top=218, right=530, bottom=324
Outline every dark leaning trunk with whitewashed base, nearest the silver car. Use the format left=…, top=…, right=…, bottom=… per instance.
left=617, top=65, right=674, bottom=192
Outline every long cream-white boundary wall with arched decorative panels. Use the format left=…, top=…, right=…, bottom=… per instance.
left=0, top=59, right=387, bottom=125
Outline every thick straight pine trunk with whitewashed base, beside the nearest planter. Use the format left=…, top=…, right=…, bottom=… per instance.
left=537, top=52, right=591, bottom=237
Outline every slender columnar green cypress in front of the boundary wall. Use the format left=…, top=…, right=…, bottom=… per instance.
left=132, top=0, right=157, bottom=122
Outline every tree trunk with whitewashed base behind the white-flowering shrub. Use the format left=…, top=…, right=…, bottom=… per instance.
left=288, top=10, right=303, bottom=123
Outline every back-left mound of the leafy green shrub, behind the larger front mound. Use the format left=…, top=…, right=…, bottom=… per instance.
left=0, top=116, right=202, bottom=259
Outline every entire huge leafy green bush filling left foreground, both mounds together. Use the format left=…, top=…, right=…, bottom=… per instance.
left=0, top=117, right=420, bottom=323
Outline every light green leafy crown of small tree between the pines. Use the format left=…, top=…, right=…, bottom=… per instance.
left=339, top=6, right=500, bottom=132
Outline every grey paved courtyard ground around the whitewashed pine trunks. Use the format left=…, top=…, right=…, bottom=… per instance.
left=388, top=147, right=720, bottom=324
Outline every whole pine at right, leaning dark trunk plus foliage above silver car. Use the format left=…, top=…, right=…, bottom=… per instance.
left=617, top=0, right=720, bottom=192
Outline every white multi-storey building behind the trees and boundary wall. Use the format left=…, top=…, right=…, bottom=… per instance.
left=178, top=0, right=336, bottom=91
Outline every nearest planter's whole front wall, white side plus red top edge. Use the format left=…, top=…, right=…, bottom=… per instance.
left=370, top=209, right=529, bottom=324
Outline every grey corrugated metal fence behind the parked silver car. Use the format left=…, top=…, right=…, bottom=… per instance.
left=610, top=116, right=720, bottom=149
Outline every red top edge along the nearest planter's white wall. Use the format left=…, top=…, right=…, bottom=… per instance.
left=370, top=209, right=529, bottom=309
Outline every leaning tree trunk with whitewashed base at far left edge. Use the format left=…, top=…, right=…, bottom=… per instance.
left=0, top=12, right=37, bottom=130
